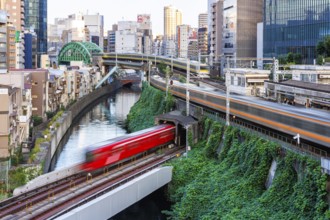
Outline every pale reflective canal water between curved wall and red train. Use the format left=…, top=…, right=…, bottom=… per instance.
left=55, top=88, right=140, bottom=170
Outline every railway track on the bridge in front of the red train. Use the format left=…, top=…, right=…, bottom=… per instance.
left=0, top=145, right=183, bottom=220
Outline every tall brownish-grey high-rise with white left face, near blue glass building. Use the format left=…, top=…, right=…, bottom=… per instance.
left=223, top=0, right=263, bottom=58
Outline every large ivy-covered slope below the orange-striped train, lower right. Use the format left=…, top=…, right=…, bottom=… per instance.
left=166, top=120, right=329, bottom=219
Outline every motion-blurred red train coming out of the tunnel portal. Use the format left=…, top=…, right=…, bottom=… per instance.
left=82, top=124, right=175, bottom=171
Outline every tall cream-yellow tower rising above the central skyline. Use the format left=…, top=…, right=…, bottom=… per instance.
left=164, top=5, right=182, bottom=40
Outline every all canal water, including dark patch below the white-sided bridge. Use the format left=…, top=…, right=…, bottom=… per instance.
left=53, top=87, right=169, bottom=220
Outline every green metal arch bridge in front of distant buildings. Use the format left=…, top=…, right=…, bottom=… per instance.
left=58, top=42, right=103, bottom=65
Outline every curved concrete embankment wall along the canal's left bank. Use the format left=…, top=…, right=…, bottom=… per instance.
left=41, top=82, right=122, bottom=173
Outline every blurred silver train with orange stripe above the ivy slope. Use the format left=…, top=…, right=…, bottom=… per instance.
left=151, top=78, right=330, bottom=148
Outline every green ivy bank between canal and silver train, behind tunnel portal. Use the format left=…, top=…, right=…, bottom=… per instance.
left=126, top=83, right=175, bottom=132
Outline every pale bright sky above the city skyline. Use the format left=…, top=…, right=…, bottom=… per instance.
left=48, top=0, right=207, bottom=35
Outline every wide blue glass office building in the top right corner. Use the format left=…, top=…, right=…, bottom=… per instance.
left=263, top=0, right=330, bottom=64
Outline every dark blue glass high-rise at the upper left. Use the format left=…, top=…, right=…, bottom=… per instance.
left=24, top=0, right=47, bottom=66
